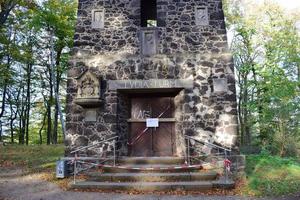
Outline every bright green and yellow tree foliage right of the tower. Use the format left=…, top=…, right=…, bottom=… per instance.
left=225, top=0, right=300, bottom=156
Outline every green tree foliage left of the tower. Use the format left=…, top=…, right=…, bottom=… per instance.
left=0, top=0, right=77, bottom=144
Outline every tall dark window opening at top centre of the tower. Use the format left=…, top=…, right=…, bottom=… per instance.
left=141, top=0, right=157, bottom=27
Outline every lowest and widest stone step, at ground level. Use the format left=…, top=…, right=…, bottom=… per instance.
left=71, top=181, right=213, bottom=191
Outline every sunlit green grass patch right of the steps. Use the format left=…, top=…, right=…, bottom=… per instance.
left=246, top=153, right=300, bottom=196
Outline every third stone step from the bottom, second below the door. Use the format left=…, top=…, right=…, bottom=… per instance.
left=101, top=165, right=203, bottom=173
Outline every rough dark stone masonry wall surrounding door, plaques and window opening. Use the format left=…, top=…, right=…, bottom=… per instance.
left=66, top=0, right=237, bottom=155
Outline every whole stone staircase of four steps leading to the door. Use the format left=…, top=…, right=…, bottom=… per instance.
left=71, top=157, right=234, bottom=191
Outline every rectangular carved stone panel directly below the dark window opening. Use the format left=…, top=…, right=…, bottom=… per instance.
left=141, top=28, right=158, bottom=56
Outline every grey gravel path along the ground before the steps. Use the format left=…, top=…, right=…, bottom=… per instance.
left=0, top=169, right=300, bottom=200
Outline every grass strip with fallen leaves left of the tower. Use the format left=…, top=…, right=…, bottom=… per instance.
left=0, top=145, right=64, bottom=172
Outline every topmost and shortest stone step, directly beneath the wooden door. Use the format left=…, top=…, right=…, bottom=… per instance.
left=117, top=157, right=185, bottom=165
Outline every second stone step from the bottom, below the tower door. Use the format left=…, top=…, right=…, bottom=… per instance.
left=87, top=171, right=217, bottom=182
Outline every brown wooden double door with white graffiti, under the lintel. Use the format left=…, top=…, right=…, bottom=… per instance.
left=129, top=97, right=175, bottom=157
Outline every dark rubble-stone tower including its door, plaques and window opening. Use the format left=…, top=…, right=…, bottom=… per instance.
left=66, top=0, right=237, bottom=156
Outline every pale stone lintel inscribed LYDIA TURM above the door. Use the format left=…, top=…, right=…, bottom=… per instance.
left=108, top=79, right=193, bottom=90
